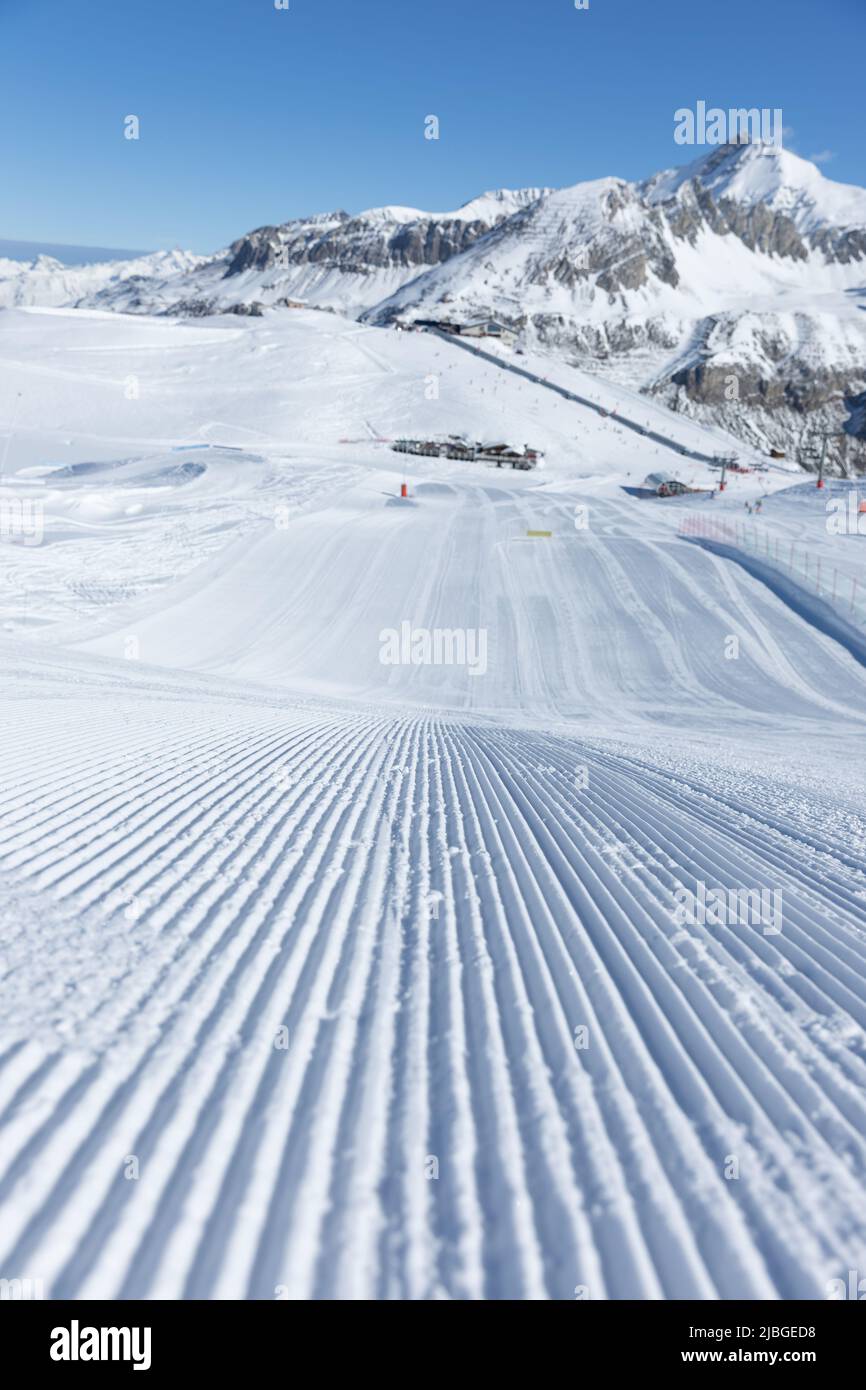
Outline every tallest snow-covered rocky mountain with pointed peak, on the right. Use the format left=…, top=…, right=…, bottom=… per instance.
left=371, top=145, right=866, bottom=471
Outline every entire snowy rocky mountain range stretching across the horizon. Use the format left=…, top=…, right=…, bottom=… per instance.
left=6, top=143, right=866, bottom=473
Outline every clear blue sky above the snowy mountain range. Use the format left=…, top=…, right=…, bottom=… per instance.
left=0, top=0, right=866, bottom=252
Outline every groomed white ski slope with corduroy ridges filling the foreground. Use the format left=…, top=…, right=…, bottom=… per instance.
left=0, top=309, right=866, bottom=1300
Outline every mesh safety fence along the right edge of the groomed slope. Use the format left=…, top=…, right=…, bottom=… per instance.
left=678, top=514, right=866, bottom=628
